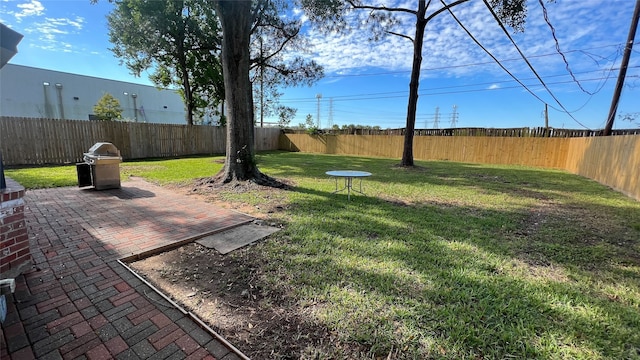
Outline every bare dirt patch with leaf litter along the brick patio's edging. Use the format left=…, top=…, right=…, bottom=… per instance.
left=131, top=243, right=350, bottom=359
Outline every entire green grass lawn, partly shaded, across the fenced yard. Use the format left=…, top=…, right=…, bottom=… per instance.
left=6, top=152, right=640, bottom=359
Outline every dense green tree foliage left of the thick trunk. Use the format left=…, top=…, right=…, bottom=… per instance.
left=107, top=0, right=224, bottom=125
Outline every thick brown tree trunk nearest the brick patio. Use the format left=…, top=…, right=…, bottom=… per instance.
left=216, top=0, right=278, bottom=186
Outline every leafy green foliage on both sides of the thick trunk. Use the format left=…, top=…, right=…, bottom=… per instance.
left=108, top=0, right=323, bottom=128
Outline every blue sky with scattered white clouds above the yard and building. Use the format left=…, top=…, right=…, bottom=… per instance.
left=0, top=0, right=640, bottom=129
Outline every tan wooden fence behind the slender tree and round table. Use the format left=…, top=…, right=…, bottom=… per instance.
left=280, top=134, right=640, bottom=200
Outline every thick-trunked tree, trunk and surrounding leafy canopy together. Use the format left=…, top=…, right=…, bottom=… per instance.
left=105, top=0, right=323, bottom=182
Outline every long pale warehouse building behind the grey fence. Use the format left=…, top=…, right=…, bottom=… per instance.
left=0, top=64, right=202, bottom=125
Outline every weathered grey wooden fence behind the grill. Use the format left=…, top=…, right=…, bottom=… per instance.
left=0, top=117, right=281, bottom=165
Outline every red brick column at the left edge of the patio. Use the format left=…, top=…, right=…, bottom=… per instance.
left=0, top=178, right=31, bottom=279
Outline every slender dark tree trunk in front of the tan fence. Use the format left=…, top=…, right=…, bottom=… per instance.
left=400, top=0, right=427, bottom=166
